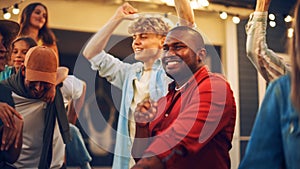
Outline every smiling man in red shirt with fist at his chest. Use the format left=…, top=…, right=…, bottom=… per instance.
left=132, top=26, right=236, bottom=169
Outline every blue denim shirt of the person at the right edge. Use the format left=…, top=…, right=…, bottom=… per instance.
left=239, top=75, right=300, bottom=169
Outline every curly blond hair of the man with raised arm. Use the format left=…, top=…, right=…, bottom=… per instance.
left=128, top=17, right=170, bottom=36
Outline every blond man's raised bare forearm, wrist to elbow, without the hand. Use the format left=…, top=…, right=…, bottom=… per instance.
left=83, top=15, right=122, bottom=59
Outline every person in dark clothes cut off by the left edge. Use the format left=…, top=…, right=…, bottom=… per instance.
left=0, top=20, right=23, bottom=169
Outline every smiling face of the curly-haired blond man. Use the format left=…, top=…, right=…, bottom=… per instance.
left=132, top=33, right=163, bottom=63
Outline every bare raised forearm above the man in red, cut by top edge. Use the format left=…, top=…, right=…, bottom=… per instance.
left=174, top=0, right=195, bottom=27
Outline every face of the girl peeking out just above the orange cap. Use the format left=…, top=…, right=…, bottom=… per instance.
left=11, top=40, right=29, bottom=70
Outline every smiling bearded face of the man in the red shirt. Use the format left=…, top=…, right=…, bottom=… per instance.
left=162, top=31, right=201, bottom=80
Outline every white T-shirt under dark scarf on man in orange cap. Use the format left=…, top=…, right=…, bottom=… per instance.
left=12, top=93, right=65, bottom=169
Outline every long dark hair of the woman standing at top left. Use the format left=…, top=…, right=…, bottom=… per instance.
left=19, top=2, right=56, bottom=45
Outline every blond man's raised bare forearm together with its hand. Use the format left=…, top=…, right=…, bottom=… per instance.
left=83, top=2, right=137, bottom=59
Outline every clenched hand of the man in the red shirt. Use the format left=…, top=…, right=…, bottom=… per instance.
left=134, top=98, right=157, bottom=126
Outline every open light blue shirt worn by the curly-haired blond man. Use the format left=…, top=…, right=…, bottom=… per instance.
left=89, top=51, right=171, bottom=169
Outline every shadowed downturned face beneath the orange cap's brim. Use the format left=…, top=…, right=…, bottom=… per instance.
left=25, top=80, right=53, bottom=99
